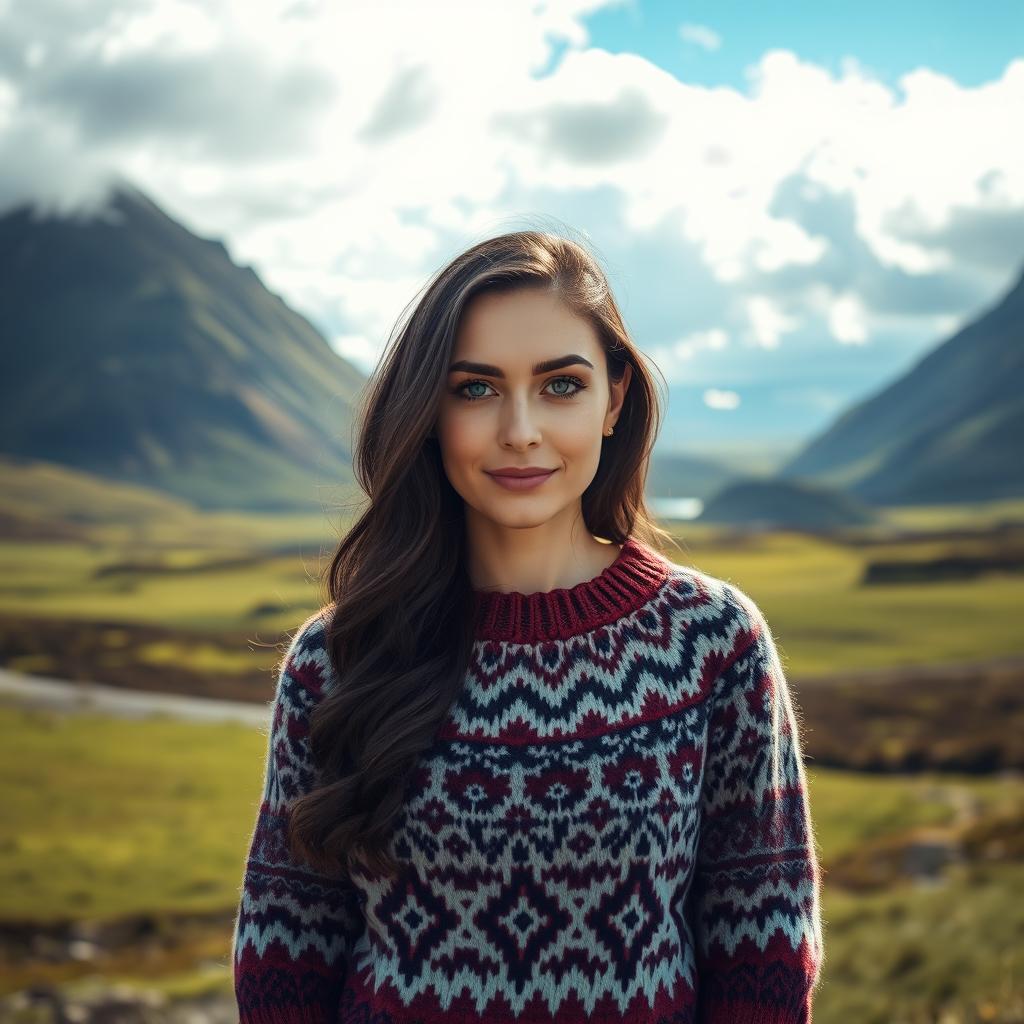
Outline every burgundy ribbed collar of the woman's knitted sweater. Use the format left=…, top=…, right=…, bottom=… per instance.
left=473, top=537, right=672, bottom=643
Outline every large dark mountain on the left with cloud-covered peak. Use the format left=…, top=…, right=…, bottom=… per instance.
left=0, top=185, right=365, bottom=511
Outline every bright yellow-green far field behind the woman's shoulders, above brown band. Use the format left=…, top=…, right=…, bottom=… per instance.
left=0, top=509, right=1024, bottom=676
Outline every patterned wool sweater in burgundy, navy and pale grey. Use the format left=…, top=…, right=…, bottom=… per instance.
left=232, top=539, right=823, bottom=1024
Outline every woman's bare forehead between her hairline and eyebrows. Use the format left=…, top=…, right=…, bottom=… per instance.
left=453, top=289, right=601, bottom=369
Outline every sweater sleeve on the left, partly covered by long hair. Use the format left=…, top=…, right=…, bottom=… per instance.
left=231, top=621, right=362, bottom=1024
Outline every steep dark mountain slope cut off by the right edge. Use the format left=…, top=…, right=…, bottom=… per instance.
left=776, top=264, right=1024, bottom=505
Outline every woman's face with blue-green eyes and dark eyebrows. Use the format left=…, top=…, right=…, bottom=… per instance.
left=437, top=289, right=632, bottom=528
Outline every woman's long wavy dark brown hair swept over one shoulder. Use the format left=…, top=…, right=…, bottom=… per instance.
left=290, top=230, right=672, bottom=878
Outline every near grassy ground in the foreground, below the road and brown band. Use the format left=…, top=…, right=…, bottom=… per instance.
left=0, top=706, right=1024, bottom=1024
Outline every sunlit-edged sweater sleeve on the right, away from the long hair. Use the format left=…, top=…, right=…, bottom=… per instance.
left=689, top=591, right=824, bottom=1024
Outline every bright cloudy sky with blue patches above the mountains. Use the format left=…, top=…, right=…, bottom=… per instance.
left=0, top=0, right=1024, bottom=454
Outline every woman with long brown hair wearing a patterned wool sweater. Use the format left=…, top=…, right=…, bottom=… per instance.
left=232, top=231, right=823, bottom=1024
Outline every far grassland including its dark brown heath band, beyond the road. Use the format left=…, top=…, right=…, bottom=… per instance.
left=0, top=505, right=1024, bottom=771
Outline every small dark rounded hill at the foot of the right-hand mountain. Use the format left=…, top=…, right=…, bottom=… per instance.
left=695, top=480, right=879, bottom=530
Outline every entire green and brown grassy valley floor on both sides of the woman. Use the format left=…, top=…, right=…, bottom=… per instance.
left=0, top=468, right=1024, bottom=1024
